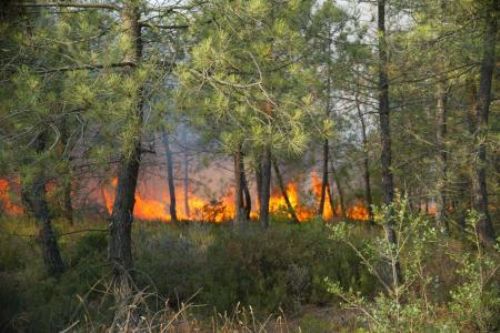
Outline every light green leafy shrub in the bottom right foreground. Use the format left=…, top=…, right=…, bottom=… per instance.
left=327, top=200, right=500, bottom=332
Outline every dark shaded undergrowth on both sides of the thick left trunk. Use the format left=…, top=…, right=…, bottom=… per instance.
left=0, top=215, right=378, bottom=332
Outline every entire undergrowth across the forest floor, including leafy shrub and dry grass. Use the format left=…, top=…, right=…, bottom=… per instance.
left=0, top=205, right=500, bottom=333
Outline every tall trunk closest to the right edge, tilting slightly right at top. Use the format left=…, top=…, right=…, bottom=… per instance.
left=473, top=0, right=499, bottom=244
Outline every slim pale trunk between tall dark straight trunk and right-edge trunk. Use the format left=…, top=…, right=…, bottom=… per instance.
left=435, top=81, right=449, bottom=232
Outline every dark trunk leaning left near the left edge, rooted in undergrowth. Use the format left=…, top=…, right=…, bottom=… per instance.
left=22, top=133, right=64, bottom=276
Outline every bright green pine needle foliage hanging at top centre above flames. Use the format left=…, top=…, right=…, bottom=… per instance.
left=177, top=0, right=313, bottom=154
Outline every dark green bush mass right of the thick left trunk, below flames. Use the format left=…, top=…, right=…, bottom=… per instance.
left=136, top=218, right=375, bottom=312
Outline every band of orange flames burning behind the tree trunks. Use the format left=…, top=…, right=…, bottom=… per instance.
left=0, top=165, right=368, bottom=223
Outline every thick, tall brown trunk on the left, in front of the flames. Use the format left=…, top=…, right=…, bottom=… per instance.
left=109, top=1, right=143, bottom=288
